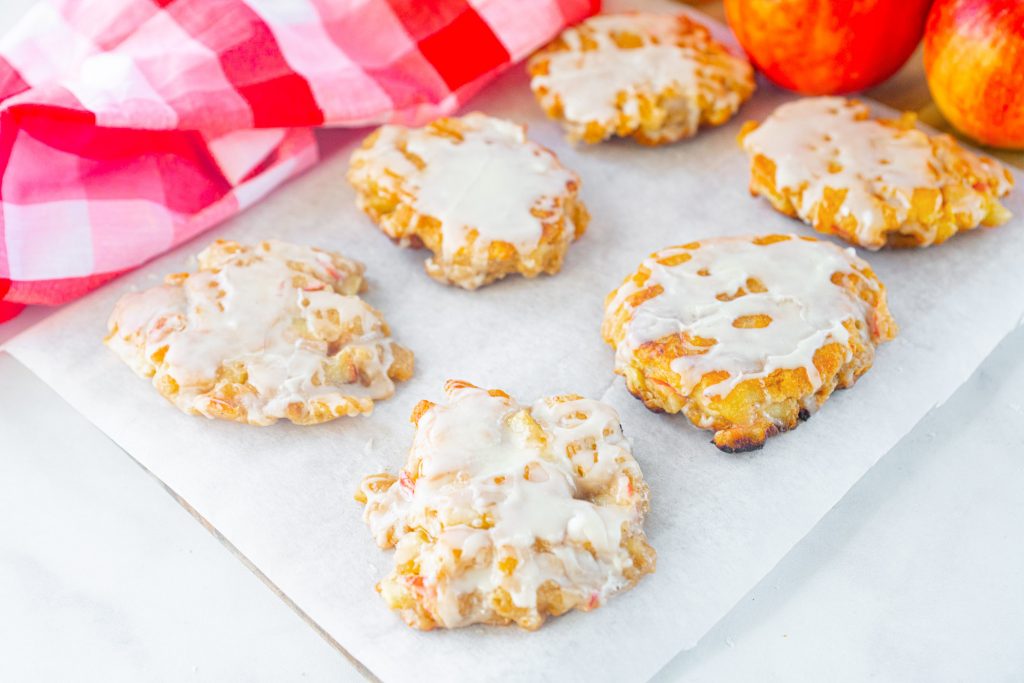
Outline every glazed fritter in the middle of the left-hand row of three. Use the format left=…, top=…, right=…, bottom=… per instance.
left=348, top=114, right=590, bottom=290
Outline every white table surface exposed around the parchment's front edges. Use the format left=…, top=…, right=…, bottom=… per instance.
left=0, top=0, right=1024, bottom=683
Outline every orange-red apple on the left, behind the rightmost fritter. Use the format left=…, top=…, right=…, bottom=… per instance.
left=725, top=0, right=931, bottom=95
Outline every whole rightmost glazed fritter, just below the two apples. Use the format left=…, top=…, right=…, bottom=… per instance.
left=739, top=97, right=1014, bottom=250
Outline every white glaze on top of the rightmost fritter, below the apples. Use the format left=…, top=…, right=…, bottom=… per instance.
left=742, top=97, right=1010, bottom=249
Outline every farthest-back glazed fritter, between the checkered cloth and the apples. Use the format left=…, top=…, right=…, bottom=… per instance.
left=527, top=12, right=755, bottom=144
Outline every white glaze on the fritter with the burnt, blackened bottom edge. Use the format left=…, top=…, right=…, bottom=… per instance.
left=607, top=236, right=873, bottom=403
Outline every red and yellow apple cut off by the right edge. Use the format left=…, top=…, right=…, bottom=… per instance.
left=925, top=0, right=1024, bottom=150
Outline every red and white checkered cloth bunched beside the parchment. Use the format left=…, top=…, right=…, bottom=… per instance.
left=0, top=0, right=600, bottom=319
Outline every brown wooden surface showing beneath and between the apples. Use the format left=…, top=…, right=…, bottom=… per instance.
left=686, top=0, right=1024, bottom=168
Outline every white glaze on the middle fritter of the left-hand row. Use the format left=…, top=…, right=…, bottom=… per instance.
left=352, top=113, right=579, bottom=264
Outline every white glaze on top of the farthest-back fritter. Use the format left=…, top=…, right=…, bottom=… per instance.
left=530, top=12, right=751, bottom=137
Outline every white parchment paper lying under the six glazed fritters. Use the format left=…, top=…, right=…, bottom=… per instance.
left=8, top=6, right=1024, bottom=681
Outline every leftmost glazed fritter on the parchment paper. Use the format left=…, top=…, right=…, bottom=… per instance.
left=105, top=241, right=413, bottom=425
